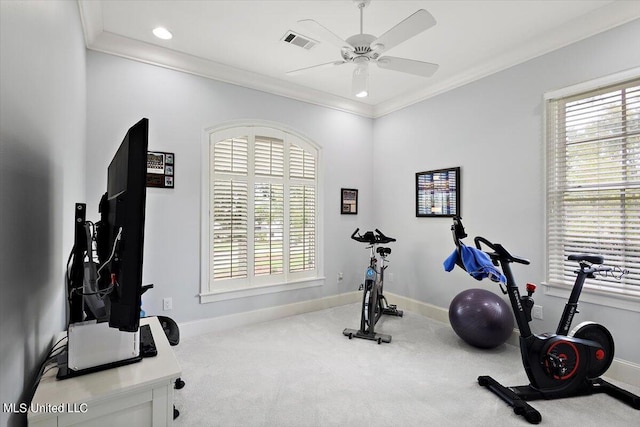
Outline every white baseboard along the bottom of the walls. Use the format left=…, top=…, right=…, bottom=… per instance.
left=179, top=292, right=640, bottom=387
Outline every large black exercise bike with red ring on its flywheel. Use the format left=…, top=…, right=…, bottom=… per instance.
left=451, top=217, right=640, bottom=424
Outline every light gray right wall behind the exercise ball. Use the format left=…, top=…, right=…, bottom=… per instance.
left=374, top=20, right=640, bottom=363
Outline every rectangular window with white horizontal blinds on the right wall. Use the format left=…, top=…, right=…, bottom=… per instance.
left=546, top=79, right=640, bottom=301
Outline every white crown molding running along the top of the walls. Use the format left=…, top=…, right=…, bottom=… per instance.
left=78, top=0, right=640, bottom=118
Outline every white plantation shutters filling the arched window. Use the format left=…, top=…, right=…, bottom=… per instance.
left=209, top=128, right=318, bottom=291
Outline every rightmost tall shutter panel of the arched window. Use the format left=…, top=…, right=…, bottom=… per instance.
left=289, top=144, right=317, bottom=273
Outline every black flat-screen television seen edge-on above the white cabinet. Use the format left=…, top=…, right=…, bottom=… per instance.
left=97, top=119, right=149, bottom=332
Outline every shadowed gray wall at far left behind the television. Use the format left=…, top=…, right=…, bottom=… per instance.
left=0, top=1, right=86, bottom=426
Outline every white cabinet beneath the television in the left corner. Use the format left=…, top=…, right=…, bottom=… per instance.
left=27, top=317, right=181, bottom=427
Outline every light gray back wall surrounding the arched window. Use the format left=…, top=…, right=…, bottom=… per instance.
left=87, top=52, right=374, bottom=322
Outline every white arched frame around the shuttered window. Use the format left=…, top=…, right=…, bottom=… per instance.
left=199, top=120, right=325, bottom=304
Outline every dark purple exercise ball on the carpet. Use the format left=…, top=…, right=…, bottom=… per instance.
left=449, top=289, right=513, bottom=348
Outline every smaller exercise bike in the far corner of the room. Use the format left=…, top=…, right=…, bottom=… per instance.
left=342, top=228, right=403, bottom=344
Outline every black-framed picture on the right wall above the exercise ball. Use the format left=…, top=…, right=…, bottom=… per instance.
left=416, top=167, right=460, bottom=217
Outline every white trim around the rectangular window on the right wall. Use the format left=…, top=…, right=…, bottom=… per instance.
left=542, top=67, right=640, bottom=313
